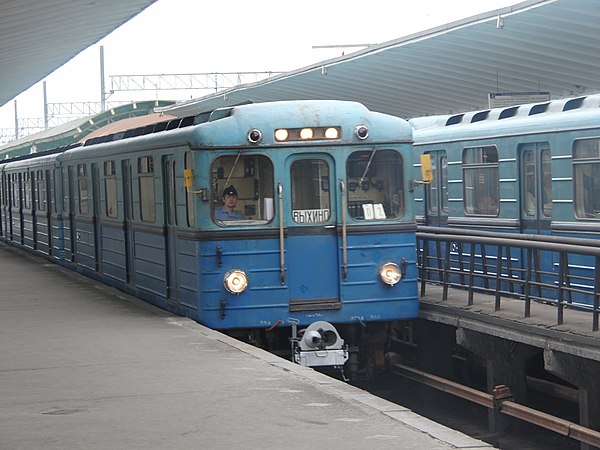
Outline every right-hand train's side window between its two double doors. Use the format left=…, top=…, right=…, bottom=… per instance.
left=462, top=145, right=500, bottom=216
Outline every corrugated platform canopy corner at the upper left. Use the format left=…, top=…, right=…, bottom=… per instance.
left=0, top=0, right=156, bottom=106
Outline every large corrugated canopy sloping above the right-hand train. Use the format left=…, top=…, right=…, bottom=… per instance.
left=162, top=0, right=600, bottom=118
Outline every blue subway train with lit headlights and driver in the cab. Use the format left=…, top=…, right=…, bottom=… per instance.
left=0, top=101, right=418, bottom=378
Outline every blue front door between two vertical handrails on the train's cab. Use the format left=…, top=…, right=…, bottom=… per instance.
left=283, top=154, right=342, bottom=311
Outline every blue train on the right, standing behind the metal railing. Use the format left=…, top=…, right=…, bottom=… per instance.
left=410, top=95, right=600, bottom=305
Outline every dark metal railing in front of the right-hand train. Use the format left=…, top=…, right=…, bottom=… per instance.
left=417, top=226, right=600, bottom=331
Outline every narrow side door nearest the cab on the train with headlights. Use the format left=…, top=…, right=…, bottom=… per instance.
left=162, top=155, right=179, bottom=305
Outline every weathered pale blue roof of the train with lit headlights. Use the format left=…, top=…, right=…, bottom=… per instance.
left=1, top=100, right=412, bottom=166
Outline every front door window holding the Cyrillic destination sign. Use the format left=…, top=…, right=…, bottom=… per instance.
left=290, top=159, right=331, bottom=224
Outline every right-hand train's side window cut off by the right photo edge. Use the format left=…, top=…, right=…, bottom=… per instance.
left=573, top=138, right=600, bottom=220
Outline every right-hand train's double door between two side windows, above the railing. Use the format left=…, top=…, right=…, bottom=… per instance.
left=519, top=142, right=552, bottom=234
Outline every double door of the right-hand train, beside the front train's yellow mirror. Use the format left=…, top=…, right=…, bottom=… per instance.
left=425, top=150, right=448, bottom=226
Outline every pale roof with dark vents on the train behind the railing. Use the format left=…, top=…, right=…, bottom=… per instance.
left=409, top=94, right=600, bottom=143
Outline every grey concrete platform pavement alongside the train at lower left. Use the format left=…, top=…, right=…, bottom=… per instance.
left=0, top=244, right=491, bottom=450
